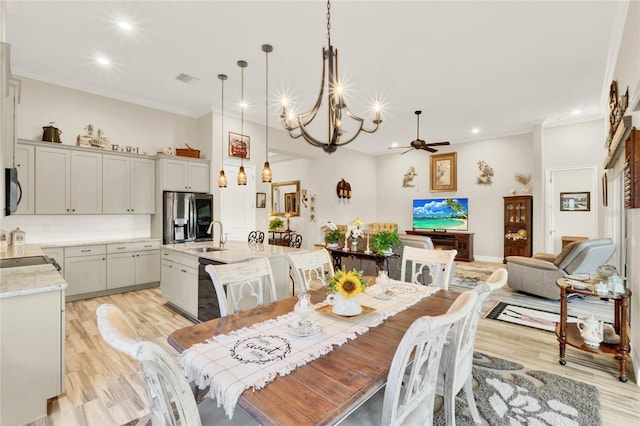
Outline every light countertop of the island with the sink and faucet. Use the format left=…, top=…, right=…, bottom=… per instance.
left=162, top=241, right=307, bottom=263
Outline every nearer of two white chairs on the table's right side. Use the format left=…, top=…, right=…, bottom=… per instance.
left=339, top=290, right=478, bottom=426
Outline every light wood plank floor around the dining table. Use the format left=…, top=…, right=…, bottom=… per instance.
left=32, top=280, right=640, bottom=426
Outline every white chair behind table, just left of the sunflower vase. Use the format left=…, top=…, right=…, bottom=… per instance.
left=287, top=249, right=334, bottom=293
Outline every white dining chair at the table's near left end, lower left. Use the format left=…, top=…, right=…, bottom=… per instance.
left=96, top=304, right=258, bottom=426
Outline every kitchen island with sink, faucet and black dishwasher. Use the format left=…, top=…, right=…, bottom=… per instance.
left=160, top=241, right=306, bottom=321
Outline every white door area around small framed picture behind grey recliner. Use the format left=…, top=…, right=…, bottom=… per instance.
left=545, top=166, right=600, bottom=253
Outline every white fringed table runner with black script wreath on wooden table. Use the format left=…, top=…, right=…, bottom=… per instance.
left=178, top=280, right=438, bottom=418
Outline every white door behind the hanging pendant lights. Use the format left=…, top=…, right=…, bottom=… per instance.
left=220, top=164, right=256, bottom=241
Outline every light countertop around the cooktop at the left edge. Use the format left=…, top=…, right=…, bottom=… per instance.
left=0, top=244, right=67, bottom=299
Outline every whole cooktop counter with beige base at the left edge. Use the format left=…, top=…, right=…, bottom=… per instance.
left=0, top=245, right=67, bottom=425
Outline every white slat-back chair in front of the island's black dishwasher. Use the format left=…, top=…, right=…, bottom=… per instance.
left=204, top=257, right=276, bottom=317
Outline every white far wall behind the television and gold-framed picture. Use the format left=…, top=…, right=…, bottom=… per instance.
left=376, top=134, right=537, bottom=262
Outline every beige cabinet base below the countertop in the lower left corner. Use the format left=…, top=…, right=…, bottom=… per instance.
left=0, top=290, right=65, bottom=425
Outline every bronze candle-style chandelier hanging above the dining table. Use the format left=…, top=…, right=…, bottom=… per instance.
left=280, top=0, right=382, bottom=154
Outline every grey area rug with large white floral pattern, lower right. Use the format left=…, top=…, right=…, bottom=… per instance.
left=433, top=352, right=601, bottom=426
